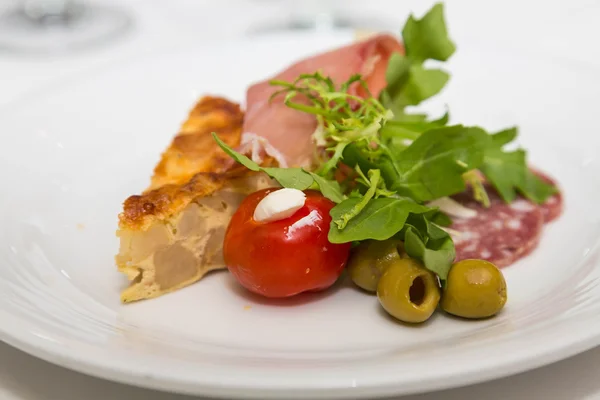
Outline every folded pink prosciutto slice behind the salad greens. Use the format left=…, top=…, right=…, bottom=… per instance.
left=243, top=35, right=404, bottom=166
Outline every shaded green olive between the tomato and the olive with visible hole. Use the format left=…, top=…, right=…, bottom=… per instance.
left=348, top=239, right=403, bottom=292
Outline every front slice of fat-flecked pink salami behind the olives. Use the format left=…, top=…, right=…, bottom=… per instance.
left=450, top=188, right=544, bottom=267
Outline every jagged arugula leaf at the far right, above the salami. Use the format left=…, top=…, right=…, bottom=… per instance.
left=481, top=128, right=557, bottom=204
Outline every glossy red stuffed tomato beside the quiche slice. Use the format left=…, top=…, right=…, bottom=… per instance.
left=223, top=188, right=350, bottom=297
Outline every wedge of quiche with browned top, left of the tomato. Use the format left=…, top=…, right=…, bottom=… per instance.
left=115, top=97, right=272, bottom=303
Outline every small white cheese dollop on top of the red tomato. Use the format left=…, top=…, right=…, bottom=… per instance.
left=254, top=188, right=306, bottom=222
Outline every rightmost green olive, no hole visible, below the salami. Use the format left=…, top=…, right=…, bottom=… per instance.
left=441, top=260, right=506, bottom=318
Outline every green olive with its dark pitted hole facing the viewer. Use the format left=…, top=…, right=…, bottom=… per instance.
left=377, top=258, right=440, bottom=323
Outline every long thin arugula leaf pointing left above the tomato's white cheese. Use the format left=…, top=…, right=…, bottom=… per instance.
left=212, top=132, right=344, bottom=203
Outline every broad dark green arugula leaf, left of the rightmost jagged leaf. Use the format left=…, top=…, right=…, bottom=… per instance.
left=387, top=125, right=489, bottom=201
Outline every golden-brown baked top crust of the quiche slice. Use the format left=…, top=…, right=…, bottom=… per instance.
left=119, top=96, right=247, bottom=230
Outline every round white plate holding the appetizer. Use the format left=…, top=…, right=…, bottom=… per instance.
left=0, top=35, right=600, bottom=398
